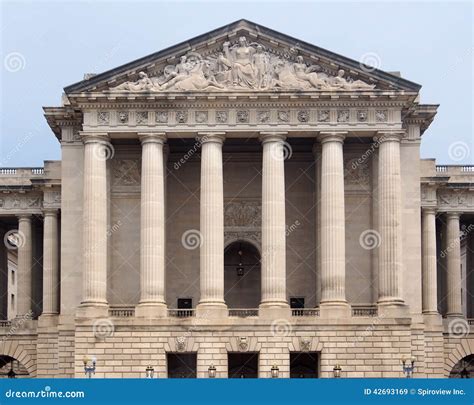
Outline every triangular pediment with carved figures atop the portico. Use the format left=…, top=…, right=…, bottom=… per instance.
left=65, top=20, right=420, bottom=95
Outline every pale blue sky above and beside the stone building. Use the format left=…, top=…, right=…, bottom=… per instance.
left=0, top=0, right=474, bottom=167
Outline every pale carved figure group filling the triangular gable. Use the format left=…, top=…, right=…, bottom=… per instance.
left=110, top=37, right=375, bottom=92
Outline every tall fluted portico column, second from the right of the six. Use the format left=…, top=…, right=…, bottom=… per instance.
left=319, top=132, right=350, bottom=317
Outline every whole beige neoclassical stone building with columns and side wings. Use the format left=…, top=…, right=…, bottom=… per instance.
left=0, top=20, right=474, bottom=378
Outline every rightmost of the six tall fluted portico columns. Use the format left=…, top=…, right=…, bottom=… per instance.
left=377, top=132, right=405, bottom=316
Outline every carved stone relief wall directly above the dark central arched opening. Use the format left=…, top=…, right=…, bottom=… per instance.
left=224, top=200, right=262, bottom=249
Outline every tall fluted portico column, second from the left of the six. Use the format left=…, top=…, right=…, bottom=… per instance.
left=136, top=133, right=166, bottom=317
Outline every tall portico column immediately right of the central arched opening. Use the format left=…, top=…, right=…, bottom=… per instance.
left=260, top=133, right=288, bottom=307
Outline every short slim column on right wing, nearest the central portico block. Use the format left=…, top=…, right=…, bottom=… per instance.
left=422, top=208, right=438, bottom=314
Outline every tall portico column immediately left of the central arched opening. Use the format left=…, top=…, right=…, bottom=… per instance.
left=196, top=132, right=227, bottom=318
